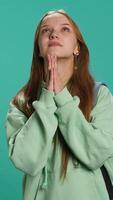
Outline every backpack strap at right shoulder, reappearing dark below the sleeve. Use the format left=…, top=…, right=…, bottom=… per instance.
left=93, top=82, right=113, bottom=200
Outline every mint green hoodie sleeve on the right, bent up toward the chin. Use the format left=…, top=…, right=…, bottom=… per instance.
left=54, top=86, right=113, bottom=170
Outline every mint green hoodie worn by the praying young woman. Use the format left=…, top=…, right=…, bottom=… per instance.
left=6, top=86, right=113, bottom=200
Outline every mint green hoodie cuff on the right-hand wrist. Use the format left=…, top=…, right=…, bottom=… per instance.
left=53, top=87, right=73, bottom=107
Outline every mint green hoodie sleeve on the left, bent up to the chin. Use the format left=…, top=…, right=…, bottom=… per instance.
left=6, top=88, right=57, bottom=176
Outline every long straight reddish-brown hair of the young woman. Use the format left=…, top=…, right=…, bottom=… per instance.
left=13, top=10, right=94, bottom=178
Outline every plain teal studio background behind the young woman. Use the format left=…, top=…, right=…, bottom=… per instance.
left=0, top=0, right=113, bottom=200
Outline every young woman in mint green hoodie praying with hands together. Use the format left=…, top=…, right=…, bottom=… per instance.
left=6, top=10, right=113, bottom=200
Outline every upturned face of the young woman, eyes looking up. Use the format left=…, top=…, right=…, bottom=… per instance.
left=38, top=13, right=78, bottom=58
